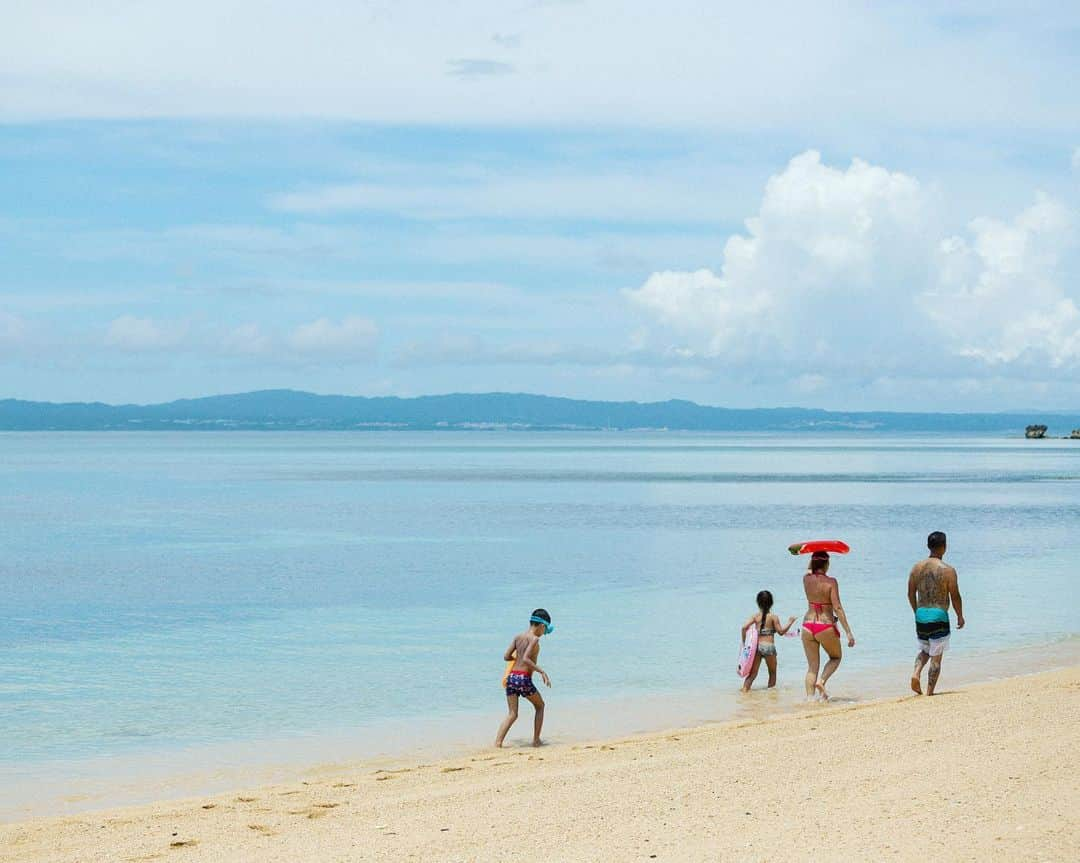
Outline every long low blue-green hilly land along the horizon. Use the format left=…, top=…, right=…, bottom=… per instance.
left=0, top=390, right=1080, bottom=435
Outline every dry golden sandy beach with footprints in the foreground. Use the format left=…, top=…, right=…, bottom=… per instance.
left=0, top=668, right=1080, bottom=863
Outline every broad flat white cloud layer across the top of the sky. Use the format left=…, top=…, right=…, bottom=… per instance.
left=0, top=0, right=1080, bottom=135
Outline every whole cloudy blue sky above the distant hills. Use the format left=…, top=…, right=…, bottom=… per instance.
left=0, top=0, right=1080, bottom=410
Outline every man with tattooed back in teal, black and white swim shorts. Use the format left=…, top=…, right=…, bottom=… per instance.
left=907, top=530, right=963, bottom=696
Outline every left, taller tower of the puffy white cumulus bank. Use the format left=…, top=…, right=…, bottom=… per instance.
left=627, top=150, right=928, bottom=362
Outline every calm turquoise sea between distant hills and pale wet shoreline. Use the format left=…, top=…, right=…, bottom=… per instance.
left=0, top=432, right=1080, bottom=803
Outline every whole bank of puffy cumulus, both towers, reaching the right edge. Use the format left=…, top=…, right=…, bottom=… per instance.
left=627, top=151, right=1080, bottom=388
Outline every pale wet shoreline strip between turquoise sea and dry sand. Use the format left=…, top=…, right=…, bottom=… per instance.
left=0, top=635, right=1080, bottom=826
